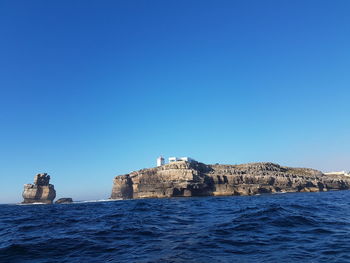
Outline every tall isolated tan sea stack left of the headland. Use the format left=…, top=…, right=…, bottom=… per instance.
left=22, top=173, right=56, bottom=204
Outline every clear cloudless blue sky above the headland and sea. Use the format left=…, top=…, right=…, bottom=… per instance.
left=0, top=0, right=350, bottom=203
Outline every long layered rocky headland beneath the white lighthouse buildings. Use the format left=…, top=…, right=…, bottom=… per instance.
left=111, top=161, right=350, bottom=199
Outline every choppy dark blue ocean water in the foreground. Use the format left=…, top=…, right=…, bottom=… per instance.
left=0, top=191, right=350, bottom=263
